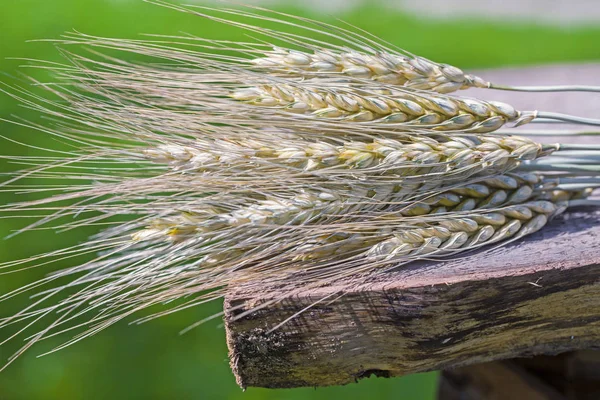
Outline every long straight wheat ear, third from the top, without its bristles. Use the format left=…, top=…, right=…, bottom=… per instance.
left=143, top=132, right=560, bottom=180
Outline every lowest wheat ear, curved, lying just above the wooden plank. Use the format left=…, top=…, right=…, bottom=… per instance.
left=295, top=180, right=592, bottom=264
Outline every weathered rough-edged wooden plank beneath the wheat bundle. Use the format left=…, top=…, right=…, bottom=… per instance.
left=225, top=67, right=600, bottom=387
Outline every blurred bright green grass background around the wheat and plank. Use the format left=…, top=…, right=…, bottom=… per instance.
left=0, top=0, right=600, bottom=400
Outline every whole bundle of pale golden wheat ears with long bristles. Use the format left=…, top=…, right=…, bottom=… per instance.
left=0, top=3, right=600, bottom=378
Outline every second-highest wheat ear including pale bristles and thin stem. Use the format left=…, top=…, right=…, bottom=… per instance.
left=39, top=50, right=598, bottom=134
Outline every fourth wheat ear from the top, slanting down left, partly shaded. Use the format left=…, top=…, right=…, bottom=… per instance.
left=132, top=173, right=552, bottom=242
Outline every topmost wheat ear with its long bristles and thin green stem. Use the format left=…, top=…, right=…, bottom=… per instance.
left=47, top=0, right=600, bottom=93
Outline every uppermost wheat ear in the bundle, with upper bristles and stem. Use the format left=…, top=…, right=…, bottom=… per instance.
left=139, top=0, right=600, bottom=93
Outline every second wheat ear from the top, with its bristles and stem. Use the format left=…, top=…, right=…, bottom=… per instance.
left=28, top=29, right=600, bottom=138
